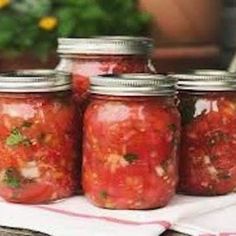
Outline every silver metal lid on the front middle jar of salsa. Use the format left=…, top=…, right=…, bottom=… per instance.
left=90, top=73, right=176, bottom=96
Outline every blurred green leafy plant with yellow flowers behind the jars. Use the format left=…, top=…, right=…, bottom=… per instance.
left=0, top=0, right=149, bottom=56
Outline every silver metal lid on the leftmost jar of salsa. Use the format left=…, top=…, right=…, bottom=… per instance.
left=0, top=70, right=71, bottom=93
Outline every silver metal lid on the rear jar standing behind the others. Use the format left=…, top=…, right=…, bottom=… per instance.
left=57, top=36, right=154, bottom=55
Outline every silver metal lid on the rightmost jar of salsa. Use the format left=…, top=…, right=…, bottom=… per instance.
left=170, top=70, right=236, bottom=91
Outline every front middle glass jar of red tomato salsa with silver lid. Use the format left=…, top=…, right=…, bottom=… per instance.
left=82, top=75, right=180, bottom=209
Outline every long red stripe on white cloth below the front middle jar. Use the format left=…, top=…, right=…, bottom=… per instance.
left=35, top=206, right=171, bottom=229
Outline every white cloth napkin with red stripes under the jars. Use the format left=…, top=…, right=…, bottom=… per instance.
left=0, top=194, right=236, bottom=236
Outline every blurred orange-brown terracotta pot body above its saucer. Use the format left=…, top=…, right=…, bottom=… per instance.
left=139, top=0, right=222, bottom=45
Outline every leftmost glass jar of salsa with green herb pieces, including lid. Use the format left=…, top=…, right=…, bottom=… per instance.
left=0, top=71, right=78, bottom=203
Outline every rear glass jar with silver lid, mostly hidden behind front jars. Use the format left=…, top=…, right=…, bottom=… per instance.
left=56, top=37, right=155, bottom=102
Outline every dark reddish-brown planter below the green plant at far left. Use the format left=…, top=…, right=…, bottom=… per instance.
left=0, top=53, right=58, bottom=71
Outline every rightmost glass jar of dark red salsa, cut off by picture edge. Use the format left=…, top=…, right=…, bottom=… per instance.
left=174, top=71, right=236, bottom=196
